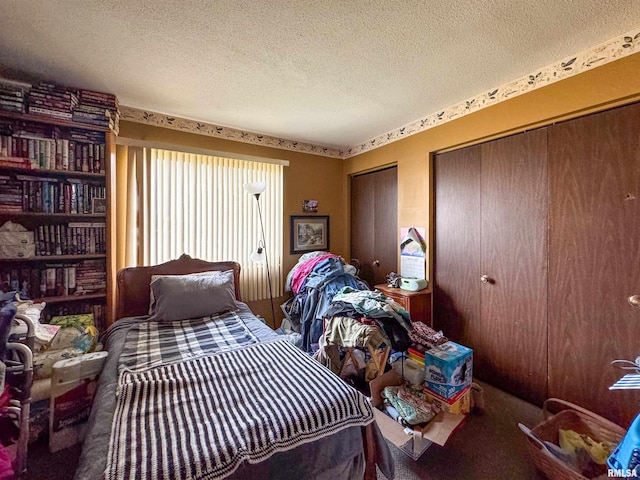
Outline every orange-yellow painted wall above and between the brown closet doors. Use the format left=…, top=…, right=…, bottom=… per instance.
left=343, top=54, right=640, bottom=278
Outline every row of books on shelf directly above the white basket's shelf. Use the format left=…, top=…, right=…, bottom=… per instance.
left=0, top=174, right=107, bottom=214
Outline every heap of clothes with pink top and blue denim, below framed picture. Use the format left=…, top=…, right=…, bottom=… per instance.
left=281, top=252, right=369, bottom=353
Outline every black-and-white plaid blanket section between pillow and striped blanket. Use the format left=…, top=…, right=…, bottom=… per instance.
left=119, top=312, right=258, bottom=370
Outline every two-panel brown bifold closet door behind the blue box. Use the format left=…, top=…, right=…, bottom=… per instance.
left=433, top=129, right=548, bottom=404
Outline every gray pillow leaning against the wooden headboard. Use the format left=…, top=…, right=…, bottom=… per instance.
left=151, top=270, right=238, bottom=320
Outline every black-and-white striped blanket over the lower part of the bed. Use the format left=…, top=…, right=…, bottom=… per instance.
left=105, top=340, right=373, bottom=480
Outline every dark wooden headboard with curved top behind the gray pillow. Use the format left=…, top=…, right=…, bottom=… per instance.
left=115, top=254, right=242, bottom=320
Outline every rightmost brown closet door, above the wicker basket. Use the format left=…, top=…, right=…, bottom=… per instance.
left=549, top=104, right=640, bottom=427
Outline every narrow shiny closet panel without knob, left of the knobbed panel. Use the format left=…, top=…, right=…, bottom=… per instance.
left=433, top=145, right=482, bottom=348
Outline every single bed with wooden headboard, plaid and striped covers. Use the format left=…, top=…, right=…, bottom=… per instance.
left=75, top=255, right=394, bottom=480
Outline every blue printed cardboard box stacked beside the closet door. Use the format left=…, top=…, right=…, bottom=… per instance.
left=424, top=341, right=473, bottom=398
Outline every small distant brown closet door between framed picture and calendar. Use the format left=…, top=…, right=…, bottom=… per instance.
left=350, top=167, right=400, bottom=287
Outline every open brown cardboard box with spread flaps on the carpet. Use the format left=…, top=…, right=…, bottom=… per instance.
left=369, top=370, right=466, bottom=460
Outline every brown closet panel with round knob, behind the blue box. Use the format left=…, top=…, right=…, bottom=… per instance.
left=482, top=129, right=548, bottom=404
